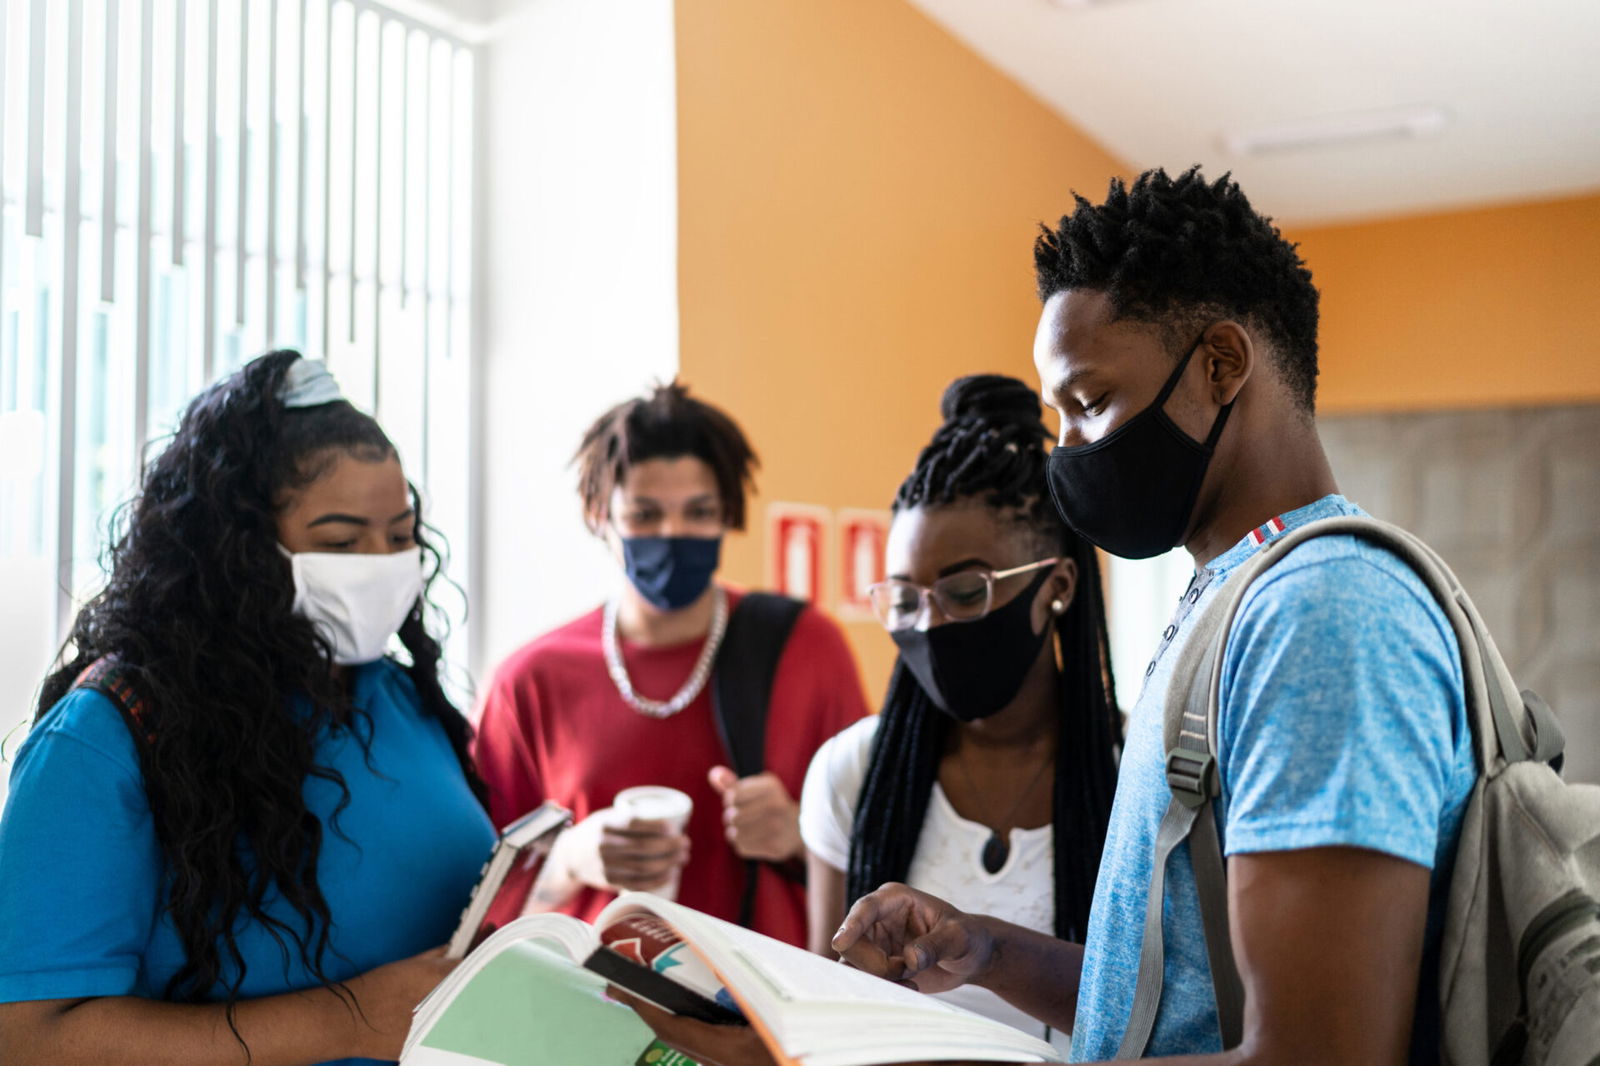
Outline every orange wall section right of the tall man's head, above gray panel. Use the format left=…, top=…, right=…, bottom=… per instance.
left=1288, top=195, right=1600, bottom=413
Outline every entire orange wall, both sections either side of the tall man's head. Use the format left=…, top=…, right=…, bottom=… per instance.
left=675, top=0, right=1600, bottom=703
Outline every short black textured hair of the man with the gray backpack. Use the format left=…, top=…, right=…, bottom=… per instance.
left=1034, top=166, right=1317, bottom=413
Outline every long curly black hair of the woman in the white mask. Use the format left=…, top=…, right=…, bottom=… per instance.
left=35, top=351, right=485, bottom=1011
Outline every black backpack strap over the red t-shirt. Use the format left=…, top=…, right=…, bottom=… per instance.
left=710, top=592, right=805, bottom=928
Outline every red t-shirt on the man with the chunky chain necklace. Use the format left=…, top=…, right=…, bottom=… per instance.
left=475, top=592, right=867, bottom=946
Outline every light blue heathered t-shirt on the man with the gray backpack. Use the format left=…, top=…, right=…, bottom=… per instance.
left=1072, top=496, right=1477, bottom=1063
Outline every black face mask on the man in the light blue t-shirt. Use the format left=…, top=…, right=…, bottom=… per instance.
left=1045, top=335, right=1234, bottom=559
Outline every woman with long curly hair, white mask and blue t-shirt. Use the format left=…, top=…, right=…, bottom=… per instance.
left=0, top=352, right=493, bottom=1066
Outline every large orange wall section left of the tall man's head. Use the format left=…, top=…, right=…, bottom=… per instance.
left=677, top=0, right=1128, bottom=706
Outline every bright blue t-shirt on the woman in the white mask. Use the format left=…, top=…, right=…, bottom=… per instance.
left=0, top=659, right=494, bottom=1063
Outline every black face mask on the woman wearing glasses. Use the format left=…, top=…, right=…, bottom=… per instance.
left=890, top=570, right=1053, bottom=722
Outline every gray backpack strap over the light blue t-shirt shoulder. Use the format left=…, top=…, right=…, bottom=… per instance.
left=1117, top=515, right=1563, bottom=1060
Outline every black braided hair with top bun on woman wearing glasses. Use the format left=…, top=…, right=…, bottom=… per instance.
left=845, top=375, right=1122, bottom=943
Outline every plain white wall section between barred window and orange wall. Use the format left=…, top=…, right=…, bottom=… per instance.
left=470, top=0, right=678, bottom=683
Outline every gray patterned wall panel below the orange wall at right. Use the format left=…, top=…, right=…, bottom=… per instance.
left=1320, top=407, right=1600, bottom=783
